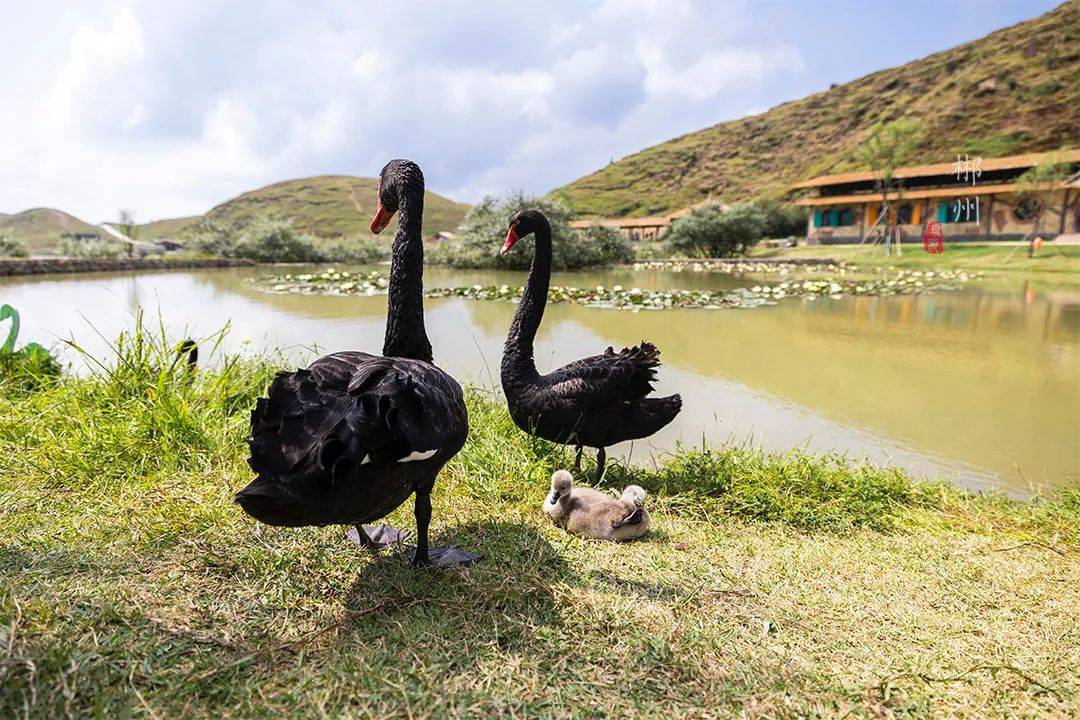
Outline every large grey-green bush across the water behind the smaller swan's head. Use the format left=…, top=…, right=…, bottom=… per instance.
left=430, top=192, right=634, bottom=270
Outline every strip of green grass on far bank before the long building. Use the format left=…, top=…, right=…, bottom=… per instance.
left=751, top=241, right=1080, bottom=276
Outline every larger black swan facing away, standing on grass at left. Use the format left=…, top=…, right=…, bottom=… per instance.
left=237, top=160, right=480, bottom=565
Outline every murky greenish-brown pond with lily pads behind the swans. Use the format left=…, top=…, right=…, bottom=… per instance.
left=0, top=268, right=1080, bottom=495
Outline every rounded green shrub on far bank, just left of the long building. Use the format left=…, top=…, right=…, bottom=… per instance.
left=661, top=203, right=766, bottom=257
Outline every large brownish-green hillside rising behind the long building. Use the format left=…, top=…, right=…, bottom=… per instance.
left=553, top=0, right=1080, bottom=217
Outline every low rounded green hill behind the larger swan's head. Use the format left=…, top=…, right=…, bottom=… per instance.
left=180, top=175, right=469, bottom=237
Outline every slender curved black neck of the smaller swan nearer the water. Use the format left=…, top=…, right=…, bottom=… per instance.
left=502, top=223, right=551, bottom=385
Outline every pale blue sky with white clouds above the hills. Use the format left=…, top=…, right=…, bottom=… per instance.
left=0, top=0, right=1057, bottom=222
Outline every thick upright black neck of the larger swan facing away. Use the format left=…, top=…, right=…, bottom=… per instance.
left=382, top=184, right=432, bottom=363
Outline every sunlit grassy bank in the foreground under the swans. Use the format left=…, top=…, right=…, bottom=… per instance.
left=0, top=342, right=1080, bottom=718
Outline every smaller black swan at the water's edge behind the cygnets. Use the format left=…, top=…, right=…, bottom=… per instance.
left=500, top=210, right=683, bottom=483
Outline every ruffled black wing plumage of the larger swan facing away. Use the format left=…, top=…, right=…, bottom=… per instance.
left=237, top=352, right=468, bottom=525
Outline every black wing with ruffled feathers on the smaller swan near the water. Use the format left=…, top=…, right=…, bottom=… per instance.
left=544, top=342, right=660, bottom=403
